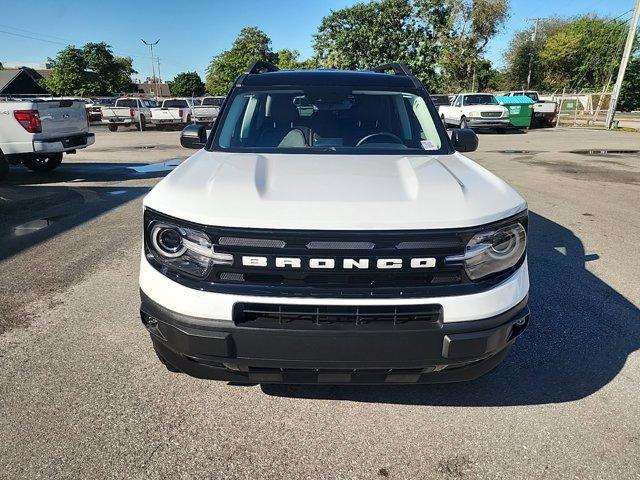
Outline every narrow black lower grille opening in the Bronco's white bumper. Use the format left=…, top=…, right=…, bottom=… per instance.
left=233, top=303, right=442, bottom=330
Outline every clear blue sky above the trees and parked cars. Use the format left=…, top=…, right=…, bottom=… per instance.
left=0, top=0, right=634, bottom=79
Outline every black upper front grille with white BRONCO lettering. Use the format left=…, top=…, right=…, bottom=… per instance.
left=145, top=209, right=527, bottom=298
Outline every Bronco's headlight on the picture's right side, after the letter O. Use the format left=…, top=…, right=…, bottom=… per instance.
left=446, top=223, right=527, bottom=280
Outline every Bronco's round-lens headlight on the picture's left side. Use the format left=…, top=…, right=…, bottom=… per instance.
left=147, top=222, right=233, bottom=278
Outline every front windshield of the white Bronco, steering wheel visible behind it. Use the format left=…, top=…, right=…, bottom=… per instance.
left=213, top=86, right=443, bottom=153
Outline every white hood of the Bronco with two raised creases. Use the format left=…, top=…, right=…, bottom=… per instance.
left=144, top=150, right=526, bottom=230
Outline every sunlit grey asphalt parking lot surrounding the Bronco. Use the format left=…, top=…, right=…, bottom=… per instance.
left=0, top=125, right=640, bottom=479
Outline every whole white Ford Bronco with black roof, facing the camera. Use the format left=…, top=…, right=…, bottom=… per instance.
left=140, top=62, right=529, bottom=384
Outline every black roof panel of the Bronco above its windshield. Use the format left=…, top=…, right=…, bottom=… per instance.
left=242, top=70, right=415, bottom=88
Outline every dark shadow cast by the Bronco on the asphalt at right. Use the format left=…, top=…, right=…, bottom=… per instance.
left=262, top=212, right=640, bottom=406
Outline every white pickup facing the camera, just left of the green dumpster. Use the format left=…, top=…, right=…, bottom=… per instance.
left=438, top=93, right=510, bottom=131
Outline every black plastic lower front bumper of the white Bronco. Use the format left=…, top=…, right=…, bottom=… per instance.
left=141, top=293, right=529, bottom=384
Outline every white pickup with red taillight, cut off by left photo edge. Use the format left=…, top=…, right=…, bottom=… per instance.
left=0, top=100, right=95, bottom=178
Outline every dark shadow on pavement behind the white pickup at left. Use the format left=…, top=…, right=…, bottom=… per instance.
left=0, top=160, right=179, bottom=260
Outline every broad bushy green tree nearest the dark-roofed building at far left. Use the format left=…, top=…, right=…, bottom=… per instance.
left=41, top=42, right=136, bottom=97
